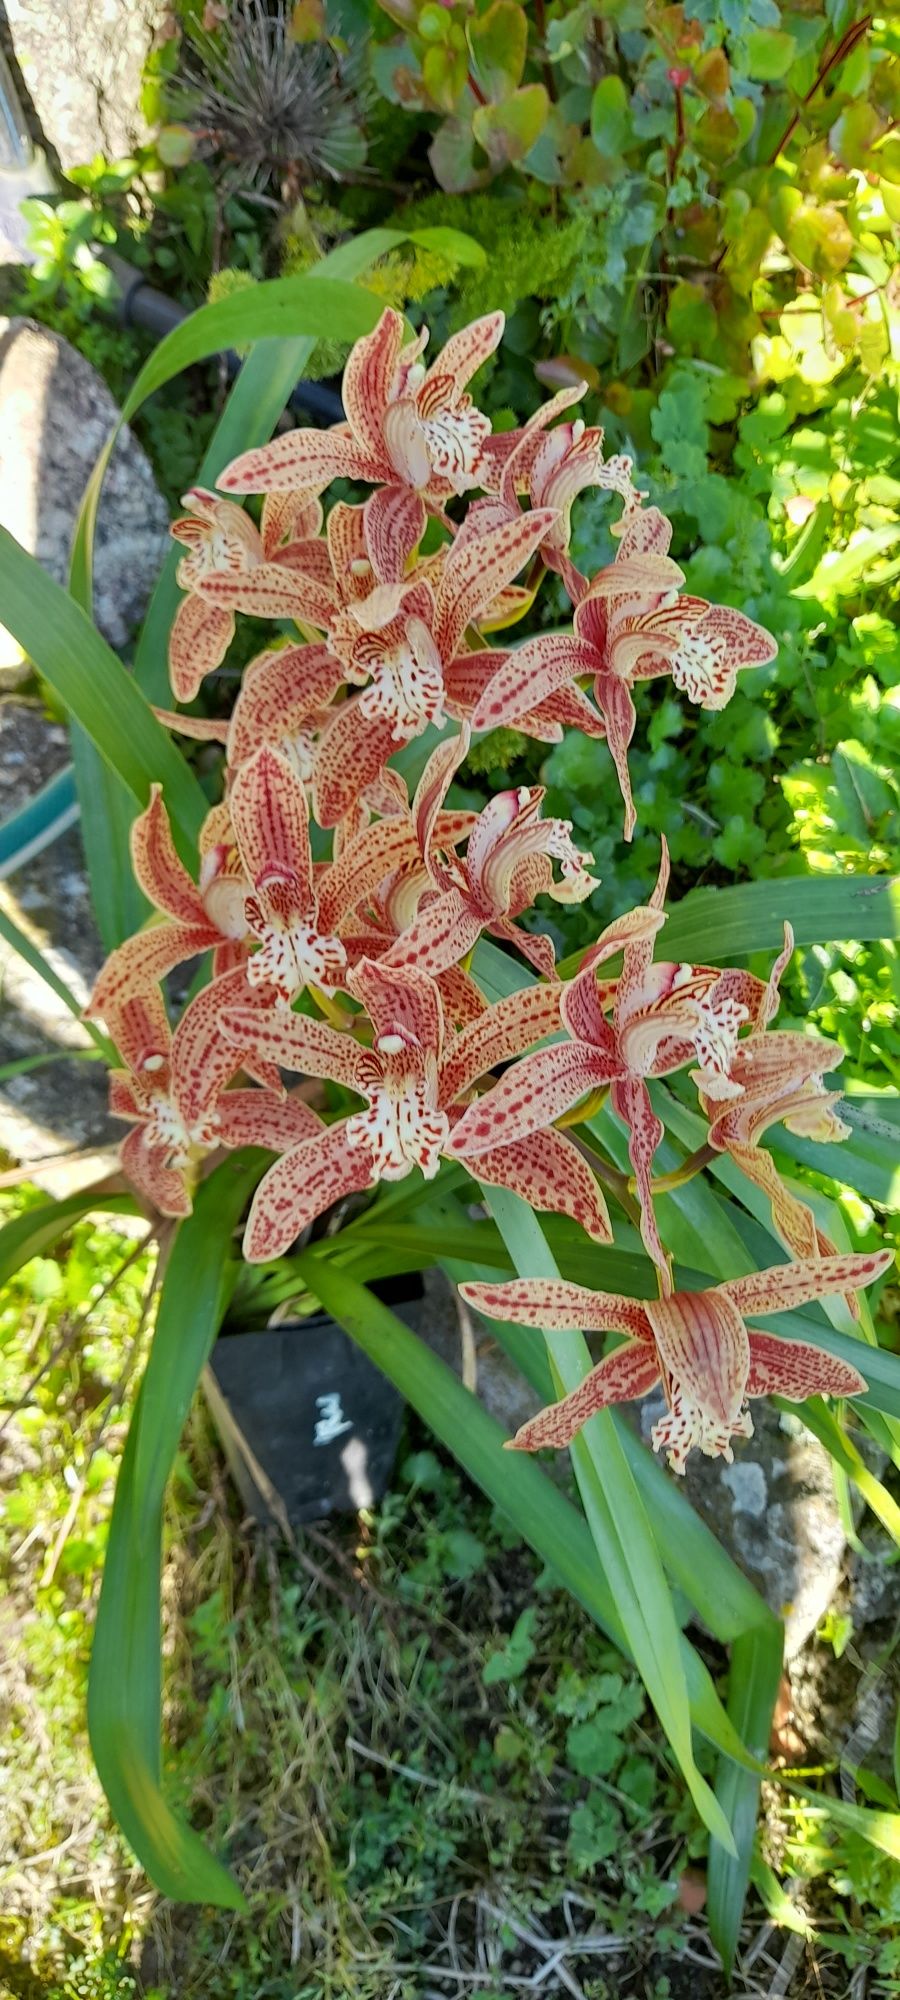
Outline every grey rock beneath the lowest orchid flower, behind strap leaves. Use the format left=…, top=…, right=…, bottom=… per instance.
left=640, top=1396, right=846, bottom=1660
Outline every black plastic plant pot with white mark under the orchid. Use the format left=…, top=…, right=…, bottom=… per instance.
left=204, top=1278, right=424, bottom=1526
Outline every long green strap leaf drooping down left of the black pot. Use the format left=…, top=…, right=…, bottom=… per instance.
left=88, top=1152, right=260, bottom=1910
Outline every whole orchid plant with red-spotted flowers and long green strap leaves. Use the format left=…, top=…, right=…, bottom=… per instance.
left=0, top=232, right=900, bottom=1958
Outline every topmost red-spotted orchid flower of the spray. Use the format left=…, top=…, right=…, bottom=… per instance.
left=218, top=306, right=504, bottom=508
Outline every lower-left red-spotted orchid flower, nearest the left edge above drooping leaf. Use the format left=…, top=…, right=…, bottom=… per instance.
left=110, top=968, right=320, bottom=1216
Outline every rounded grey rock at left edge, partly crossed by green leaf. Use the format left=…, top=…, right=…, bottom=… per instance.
left=0, top=318, right=168, bottom=688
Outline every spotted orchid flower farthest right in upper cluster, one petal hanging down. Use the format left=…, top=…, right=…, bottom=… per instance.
left=472, top=508, right=778, bottom=840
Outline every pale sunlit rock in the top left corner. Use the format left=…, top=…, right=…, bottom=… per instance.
left=6, top=0, right=164, bottom=170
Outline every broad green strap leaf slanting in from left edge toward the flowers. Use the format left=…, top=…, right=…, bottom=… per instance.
left=0, top=528, right=206, bottom=852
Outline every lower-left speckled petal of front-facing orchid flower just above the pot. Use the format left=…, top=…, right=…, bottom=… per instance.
left=244, top=1120, right=376, bottom=1264
